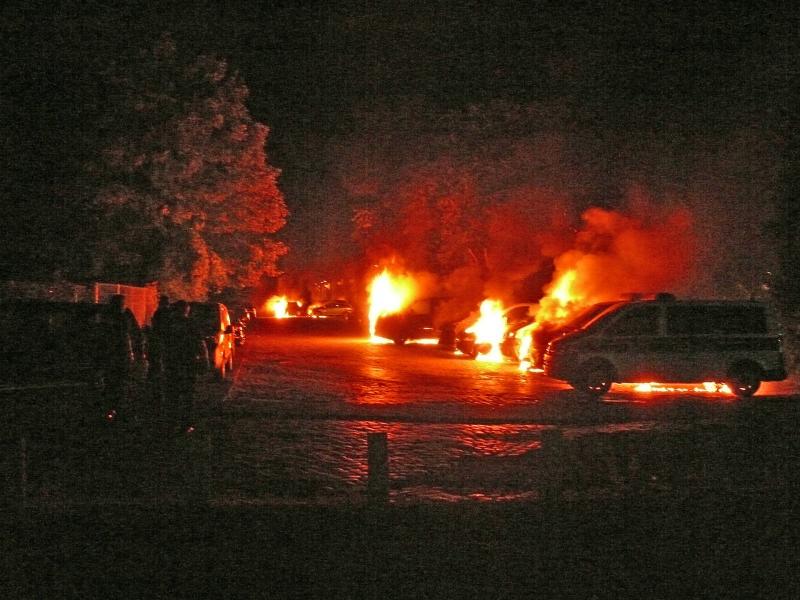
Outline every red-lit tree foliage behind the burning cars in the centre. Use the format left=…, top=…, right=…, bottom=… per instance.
left=346, top=102, right=586, bottom=296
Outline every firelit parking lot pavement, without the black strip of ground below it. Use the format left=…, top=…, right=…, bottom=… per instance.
left=4, top=324, right=800, bottom=507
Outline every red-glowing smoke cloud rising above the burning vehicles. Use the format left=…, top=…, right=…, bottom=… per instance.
left=304, top=101, right=775, bottom=302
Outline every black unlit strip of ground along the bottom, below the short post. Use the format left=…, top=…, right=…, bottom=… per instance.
left=6, top=493, right=800, bottom=598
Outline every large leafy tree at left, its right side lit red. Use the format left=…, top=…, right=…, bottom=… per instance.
left=88, top=35, right=287, bottom=299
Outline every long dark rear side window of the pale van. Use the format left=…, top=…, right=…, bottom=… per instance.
left=667, top=304, right=767, bottom=335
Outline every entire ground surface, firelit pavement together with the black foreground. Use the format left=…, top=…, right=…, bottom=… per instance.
left=6, top=320, right=800, bottom=599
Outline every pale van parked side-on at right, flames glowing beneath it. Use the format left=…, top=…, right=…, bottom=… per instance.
left=544, top=294, right=786, bottom=397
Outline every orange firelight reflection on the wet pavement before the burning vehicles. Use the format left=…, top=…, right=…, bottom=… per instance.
left=218, top=322, right=796, bottom=503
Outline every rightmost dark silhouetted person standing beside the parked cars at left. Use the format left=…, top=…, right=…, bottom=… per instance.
left=164, top=300, right=200, bottom=431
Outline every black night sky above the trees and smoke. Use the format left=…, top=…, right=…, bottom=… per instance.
left=0, top=0, right=798, bottom=288
